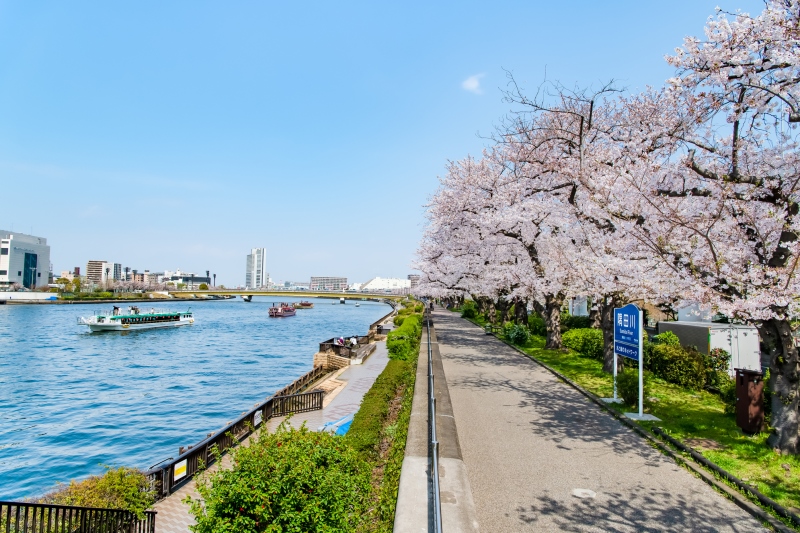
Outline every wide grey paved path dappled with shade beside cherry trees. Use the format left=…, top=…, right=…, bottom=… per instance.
left=434, top=310, right=764, bottom=533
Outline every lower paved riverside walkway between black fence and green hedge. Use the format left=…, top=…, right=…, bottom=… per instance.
left=154, top=341, right=389, bottom=533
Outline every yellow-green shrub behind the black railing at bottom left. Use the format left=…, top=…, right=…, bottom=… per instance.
left=38, top=466, right=155, bottom=518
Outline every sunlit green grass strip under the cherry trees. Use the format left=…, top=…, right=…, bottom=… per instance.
left=450, top=316, right=800, bottom=512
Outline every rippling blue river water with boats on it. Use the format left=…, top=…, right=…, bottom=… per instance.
left=0, top=296, right=391, bottom=500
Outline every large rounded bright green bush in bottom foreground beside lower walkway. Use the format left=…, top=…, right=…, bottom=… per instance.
left=184, top=423, right=371, bottom=533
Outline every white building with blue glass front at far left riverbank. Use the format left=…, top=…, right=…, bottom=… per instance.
left=0, top=230, right=50, bottom=289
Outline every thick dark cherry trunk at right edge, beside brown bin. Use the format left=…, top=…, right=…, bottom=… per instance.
left=758, top=319, right=800, bottom=454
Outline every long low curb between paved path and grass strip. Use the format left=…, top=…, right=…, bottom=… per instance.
left=464, top=319, right=800, bottom=533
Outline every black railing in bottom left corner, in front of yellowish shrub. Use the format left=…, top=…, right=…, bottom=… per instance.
left=0, top=501, right=156, bottom=533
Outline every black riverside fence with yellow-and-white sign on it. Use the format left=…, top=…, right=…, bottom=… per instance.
left=147, top=384, right=326, bottom=496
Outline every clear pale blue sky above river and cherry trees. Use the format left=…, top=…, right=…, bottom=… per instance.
left=0, top=0, right=763, bottom=285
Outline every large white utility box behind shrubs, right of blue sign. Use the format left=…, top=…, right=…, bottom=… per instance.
left=658, top=321, right=761, bottom=377
